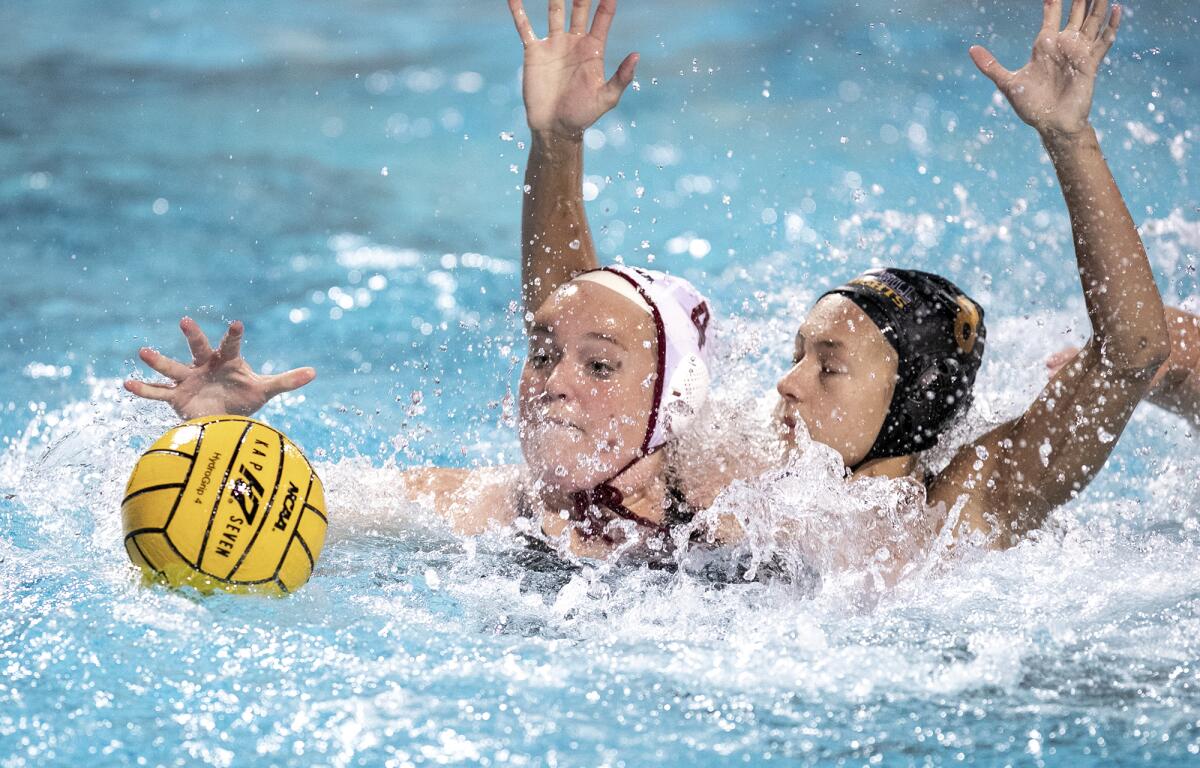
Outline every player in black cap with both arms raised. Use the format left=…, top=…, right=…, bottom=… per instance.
left=509, top=0, right=1169, bottom=546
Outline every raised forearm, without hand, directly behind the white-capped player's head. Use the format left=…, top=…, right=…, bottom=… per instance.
left=521, top=131, right=598, bottom=312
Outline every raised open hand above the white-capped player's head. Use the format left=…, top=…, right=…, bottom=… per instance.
left=509, top=0, right=637, bottom=138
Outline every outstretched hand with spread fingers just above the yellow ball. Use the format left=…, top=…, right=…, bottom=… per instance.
left=125, top=317, right=317, bottom=420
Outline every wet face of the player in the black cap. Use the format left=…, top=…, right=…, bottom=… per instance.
left=775, top=294, right=898, bottom=467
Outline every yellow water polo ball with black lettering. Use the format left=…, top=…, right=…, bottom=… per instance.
left=121, top=416, right=326, bottom=594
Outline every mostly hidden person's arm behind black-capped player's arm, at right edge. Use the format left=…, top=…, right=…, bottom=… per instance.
left=1046, top=307, right=1200, bottom=428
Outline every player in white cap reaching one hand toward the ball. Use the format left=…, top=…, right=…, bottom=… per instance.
left=125, top=266, right=709, bottom=563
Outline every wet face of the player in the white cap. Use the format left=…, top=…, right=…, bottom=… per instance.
left=520, top=281, right=658, bottom=491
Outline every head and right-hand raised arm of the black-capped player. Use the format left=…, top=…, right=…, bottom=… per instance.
left=778, top=0, right=1170, bottom=546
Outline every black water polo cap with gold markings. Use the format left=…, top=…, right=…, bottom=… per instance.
left=822, top=268, right=988, bottom=463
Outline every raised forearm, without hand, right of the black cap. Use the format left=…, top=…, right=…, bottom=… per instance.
left=1043, top=127, right=1169, bottom=368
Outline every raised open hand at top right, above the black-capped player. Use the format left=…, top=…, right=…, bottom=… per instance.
left=971, top=0, right=1121, bottom=136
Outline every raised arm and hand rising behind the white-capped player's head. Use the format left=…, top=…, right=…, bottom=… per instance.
left=509, top=0, right=637, bottom=321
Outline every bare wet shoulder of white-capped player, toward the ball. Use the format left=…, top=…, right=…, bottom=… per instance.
left=401, top=466, right=521, bottom=535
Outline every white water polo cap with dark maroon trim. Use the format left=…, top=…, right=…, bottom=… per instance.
left=575, top=266, right=712, bottom=454
